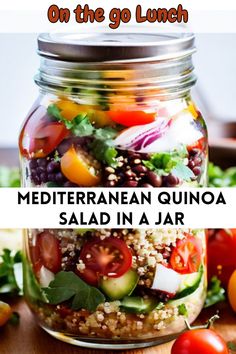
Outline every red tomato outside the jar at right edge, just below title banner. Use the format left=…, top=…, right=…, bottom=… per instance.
left=207, top=229, right=236, bottom=287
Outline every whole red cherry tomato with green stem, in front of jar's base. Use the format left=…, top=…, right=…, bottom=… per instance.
left=171, top=329, right=229, bottom=354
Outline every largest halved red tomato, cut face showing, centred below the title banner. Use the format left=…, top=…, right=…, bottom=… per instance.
left=80, top=237, right=132, bottom=285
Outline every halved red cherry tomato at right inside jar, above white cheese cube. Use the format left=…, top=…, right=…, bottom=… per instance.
left=170, top=236, right=202, bottom=274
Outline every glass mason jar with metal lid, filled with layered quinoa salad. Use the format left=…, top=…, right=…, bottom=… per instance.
left=19, top=33, right=207, bottom=349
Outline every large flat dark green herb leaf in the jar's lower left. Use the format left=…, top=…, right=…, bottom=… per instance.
left=43, top=271, right=105, bottom=311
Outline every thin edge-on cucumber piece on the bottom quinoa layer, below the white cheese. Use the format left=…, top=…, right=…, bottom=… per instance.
left=121, top=296, right=158, bottom=313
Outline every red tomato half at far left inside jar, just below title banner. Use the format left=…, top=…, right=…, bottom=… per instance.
left=34, top=231, right=62, bottom=273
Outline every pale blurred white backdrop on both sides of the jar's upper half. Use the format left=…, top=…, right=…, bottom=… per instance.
left=0, top=33, right=236, bottom=158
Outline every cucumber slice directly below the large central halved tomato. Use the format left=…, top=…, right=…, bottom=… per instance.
left=100, top=269, right=139, bottom=300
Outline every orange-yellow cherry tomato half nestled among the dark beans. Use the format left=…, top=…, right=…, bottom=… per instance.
left=61, top=146, right=101, bottom=187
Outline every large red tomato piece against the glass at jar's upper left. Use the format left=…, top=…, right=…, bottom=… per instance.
left=19, top=106, right=68, bottom=158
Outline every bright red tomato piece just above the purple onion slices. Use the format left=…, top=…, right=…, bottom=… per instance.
left=107, top=111, right=157, bottom=127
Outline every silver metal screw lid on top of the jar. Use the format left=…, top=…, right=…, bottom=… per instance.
left=38, top=27, right=195, bottom=63
